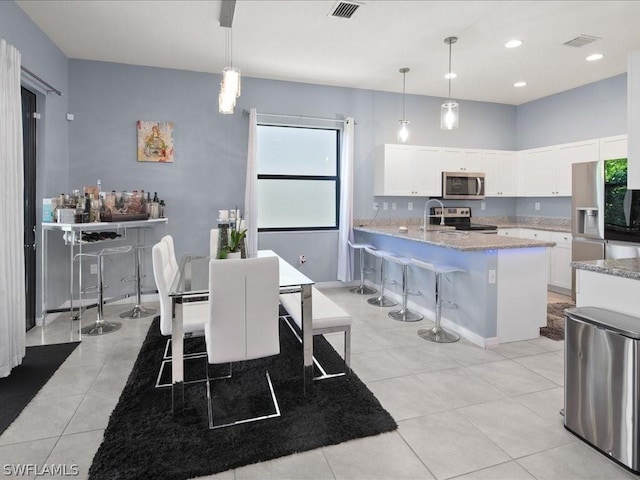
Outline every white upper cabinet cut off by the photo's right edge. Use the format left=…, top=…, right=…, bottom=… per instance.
left=627, top=51, right=640, bottom=190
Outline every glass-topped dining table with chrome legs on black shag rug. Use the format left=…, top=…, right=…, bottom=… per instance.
left=169, top=250, right=314, bottom=415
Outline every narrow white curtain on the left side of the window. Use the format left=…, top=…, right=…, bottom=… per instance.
left=244, top=108, right=258, bottom=257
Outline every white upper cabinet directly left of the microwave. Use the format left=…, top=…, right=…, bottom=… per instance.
left=373, top=144, right=442, bottom=197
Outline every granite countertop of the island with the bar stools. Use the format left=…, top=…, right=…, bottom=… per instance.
left=353, top=225, right=555, bottom=251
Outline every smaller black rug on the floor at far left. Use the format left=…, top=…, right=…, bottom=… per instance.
left=0, top=342, right=79, bottom=434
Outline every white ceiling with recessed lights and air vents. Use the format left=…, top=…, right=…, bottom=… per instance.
left=17, top=0, right=640, bottom=105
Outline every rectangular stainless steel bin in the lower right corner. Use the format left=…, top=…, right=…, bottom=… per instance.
left=564, top=307, right=640, bottom=473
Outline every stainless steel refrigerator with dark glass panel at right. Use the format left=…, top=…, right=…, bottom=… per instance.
left=571, top=159, right=640, bottom=300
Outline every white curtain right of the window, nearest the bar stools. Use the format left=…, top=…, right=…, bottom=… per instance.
left=338, top=117, right=355, bottom=282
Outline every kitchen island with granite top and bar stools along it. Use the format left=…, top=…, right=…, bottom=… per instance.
left=353, top=225, right=554, bottom=348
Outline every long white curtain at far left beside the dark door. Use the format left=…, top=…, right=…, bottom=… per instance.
left=0, top=40, right=25, bottom=378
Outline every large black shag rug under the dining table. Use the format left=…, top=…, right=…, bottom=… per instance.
left=89, top=318, right=397, bottom=480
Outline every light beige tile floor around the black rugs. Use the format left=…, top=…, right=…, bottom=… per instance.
left=0, top=289, right=636, bottom=480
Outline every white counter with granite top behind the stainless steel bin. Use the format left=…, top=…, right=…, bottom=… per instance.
left=571, top=258, right=640, bottom=317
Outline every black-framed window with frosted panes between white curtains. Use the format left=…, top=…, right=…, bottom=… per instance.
left=257, top=125, right=340, bottom=231
